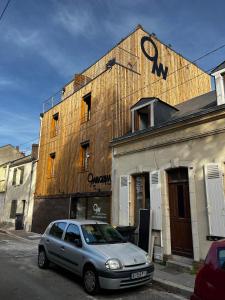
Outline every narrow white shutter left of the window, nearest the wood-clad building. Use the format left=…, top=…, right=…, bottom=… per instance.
left=119, top=175, right=130, bottom=226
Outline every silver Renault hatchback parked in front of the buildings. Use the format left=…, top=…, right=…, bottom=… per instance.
left=38, top=220, right=154, bottom=295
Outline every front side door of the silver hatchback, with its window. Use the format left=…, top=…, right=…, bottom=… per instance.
left=63, top=223, right=83, bottom=275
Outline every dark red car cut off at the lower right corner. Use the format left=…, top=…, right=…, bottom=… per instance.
left=191, top=240, right=225, bottom=300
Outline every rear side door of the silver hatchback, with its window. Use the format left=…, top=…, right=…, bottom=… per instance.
left=45, top=222, right=67, bottom=265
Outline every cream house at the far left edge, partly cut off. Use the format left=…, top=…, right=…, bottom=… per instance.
left=0, top=145, right=24, bottom=222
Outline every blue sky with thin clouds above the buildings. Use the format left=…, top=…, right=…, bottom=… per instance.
left=0, top=0, right=225, bottom=152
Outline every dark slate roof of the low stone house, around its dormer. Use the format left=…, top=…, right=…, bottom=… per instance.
left=112, top=91, right=219, bottom=144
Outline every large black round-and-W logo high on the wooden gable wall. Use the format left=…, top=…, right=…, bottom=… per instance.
left=141, top=36, right=168, bottom=80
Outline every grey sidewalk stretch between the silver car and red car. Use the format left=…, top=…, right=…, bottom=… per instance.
left=153, top=263, right=195, bottom=299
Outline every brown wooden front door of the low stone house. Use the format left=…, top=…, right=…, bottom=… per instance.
left=168, top=168, right=193, bottom=258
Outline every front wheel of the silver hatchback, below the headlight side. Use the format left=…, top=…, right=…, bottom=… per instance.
left=83, top=267, right=99, bottom=295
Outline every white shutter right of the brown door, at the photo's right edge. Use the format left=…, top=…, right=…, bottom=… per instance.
left=204, top=163, right=225, bottom=237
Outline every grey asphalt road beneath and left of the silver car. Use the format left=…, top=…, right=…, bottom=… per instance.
left=0, top=233, right=184, bottom=300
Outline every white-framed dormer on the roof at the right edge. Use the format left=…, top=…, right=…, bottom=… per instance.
left=211, top=61, right=225, bottom=105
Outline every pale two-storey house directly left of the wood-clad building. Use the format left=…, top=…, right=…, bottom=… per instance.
left=3, top=144, right=38, bottom=231
